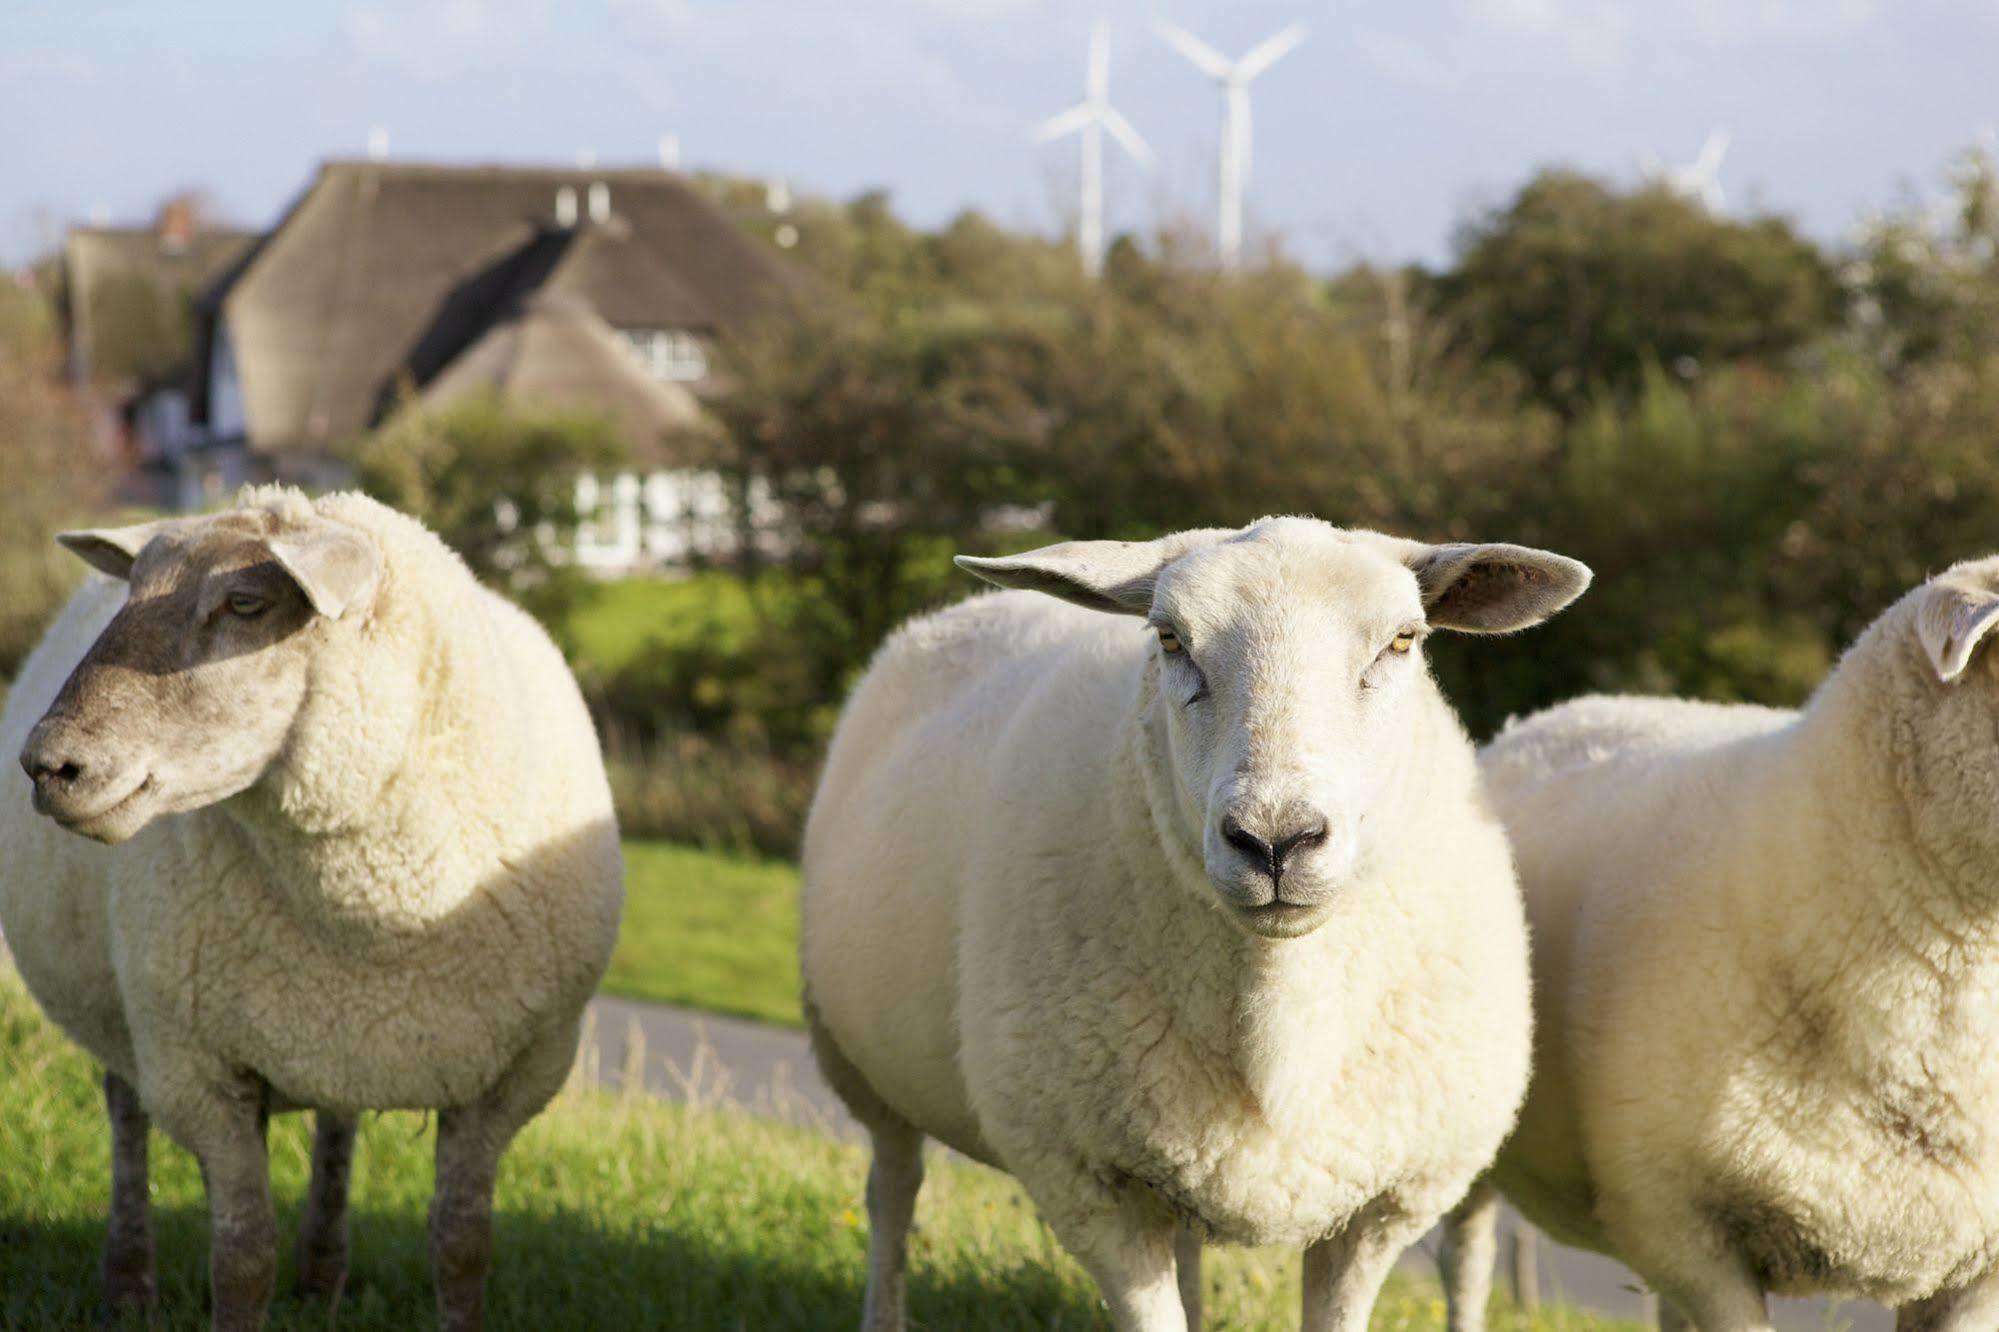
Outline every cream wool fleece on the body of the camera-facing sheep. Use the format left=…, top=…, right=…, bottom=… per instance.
left=804, top=556, right=1529, bottom=1246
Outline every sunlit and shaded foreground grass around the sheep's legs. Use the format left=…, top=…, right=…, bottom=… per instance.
left=0, top=968, right=1633, bottom=1332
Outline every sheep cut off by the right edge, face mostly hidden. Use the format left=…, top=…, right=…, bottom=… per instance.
left=1451, top=558, right=1999, bottom=1332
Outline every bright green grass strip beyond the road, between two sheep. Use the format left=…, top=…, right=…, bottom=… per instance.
left=604, top=840, right=804, bottom=1026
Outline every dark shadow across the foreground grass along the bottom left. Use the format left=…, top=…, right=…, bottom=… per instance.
left=0, top=1200, right=1105, bottom=1332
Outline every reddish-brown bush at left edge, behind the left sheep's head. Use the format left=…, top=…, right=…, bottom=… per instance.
left=0, top=284, right=104, bottom=680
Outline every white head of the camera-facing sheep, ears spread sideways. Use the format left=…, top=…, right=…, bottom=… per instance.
left=960, top=518, right=1589, bottom=938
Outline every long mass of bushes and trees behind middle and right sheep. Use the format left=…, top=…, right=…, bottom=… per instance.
left=646, top=156, right=1999, bottom=752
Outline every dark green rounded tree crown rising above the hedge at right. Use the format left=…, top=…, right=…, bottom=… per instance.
left=1437, top=170, right=1837, bottom=406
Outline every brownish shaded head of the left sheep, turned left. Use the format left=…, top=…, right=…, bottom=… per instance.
left=20, top=508, right=380, bottom=842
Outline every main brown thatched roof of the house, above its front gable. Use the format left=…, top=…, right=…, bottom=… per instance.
left=196, top=162, right=802, bottom=452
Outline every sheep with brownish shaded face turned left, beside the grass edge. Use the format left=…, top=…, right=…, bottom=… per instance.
left=0, top=488, right=624, bottom=1328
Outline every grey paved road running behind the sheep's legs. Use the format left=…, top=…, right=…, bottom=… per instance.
left=590, top=996, right=1893, bottom=1332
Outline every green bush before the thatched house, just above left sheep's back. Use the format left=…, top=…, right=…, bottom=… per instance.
left=352, top=392, right=626, bottom=608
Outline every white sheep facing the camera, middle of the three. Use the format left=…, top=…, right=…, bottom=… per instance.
left=802, top=518, right=1589, bottom=1332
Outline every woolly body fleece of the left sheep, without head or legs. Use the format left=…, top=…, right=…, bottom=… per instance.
left=0, top=488, right=624, bottom=1136
